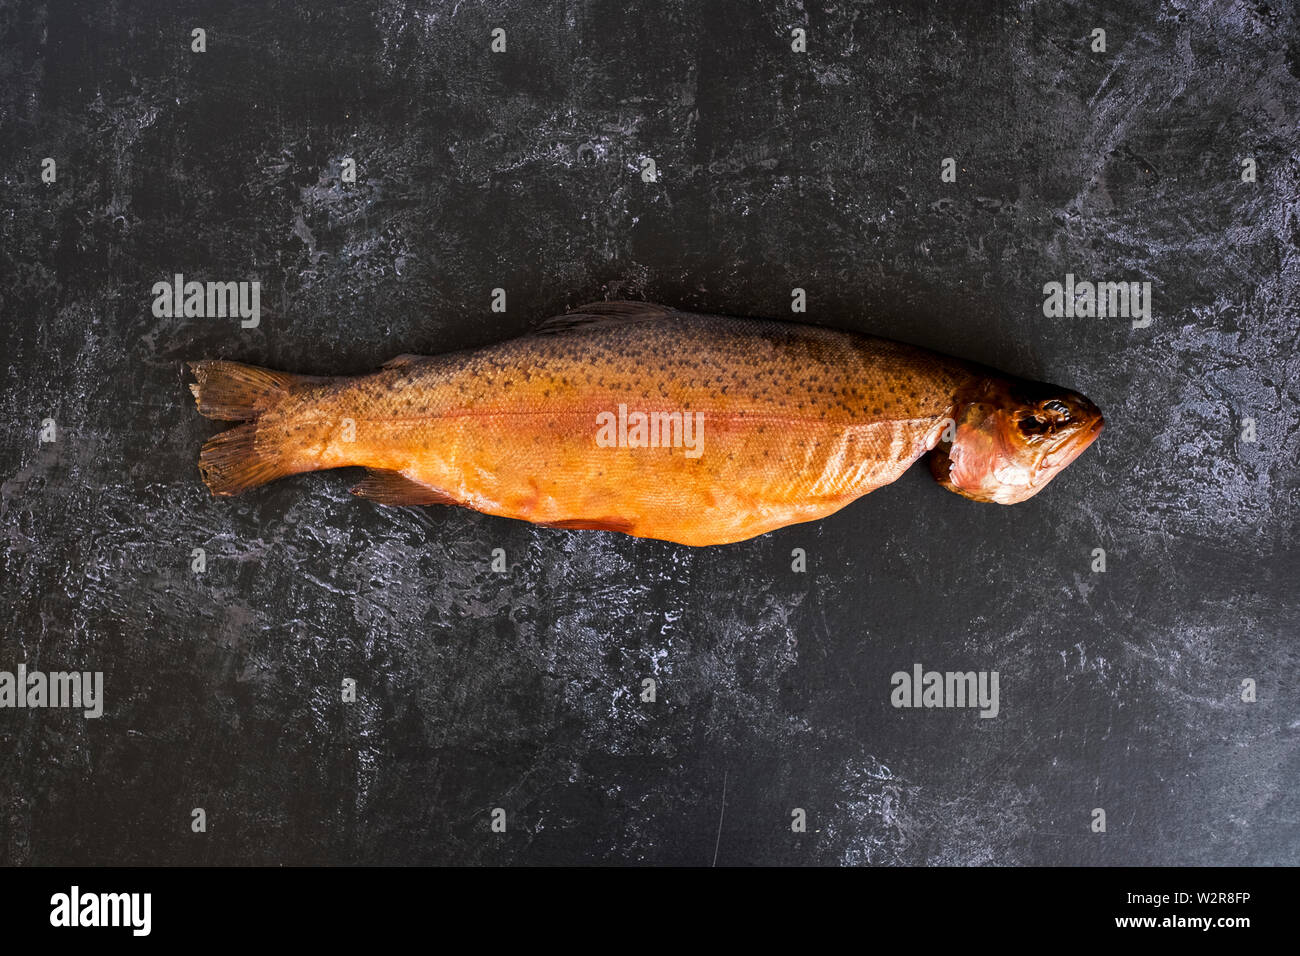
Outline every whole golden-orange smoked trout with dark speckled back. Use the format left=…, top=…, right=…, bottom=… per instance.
left=190, top=302, right=1102, bottom=545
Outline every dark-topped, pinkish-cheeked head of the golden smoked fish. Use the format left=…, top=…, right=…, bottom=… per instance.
left=930, top=377, right=1105, bottom=505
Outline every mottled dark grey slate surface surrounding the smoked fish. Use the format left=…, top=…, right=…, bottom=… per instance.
left=0, top=0, right=1300, bottom=864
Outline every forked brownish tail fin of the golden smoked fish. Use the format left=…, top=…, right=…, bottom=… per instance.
left=190, top=360, right=311, bottom=496
